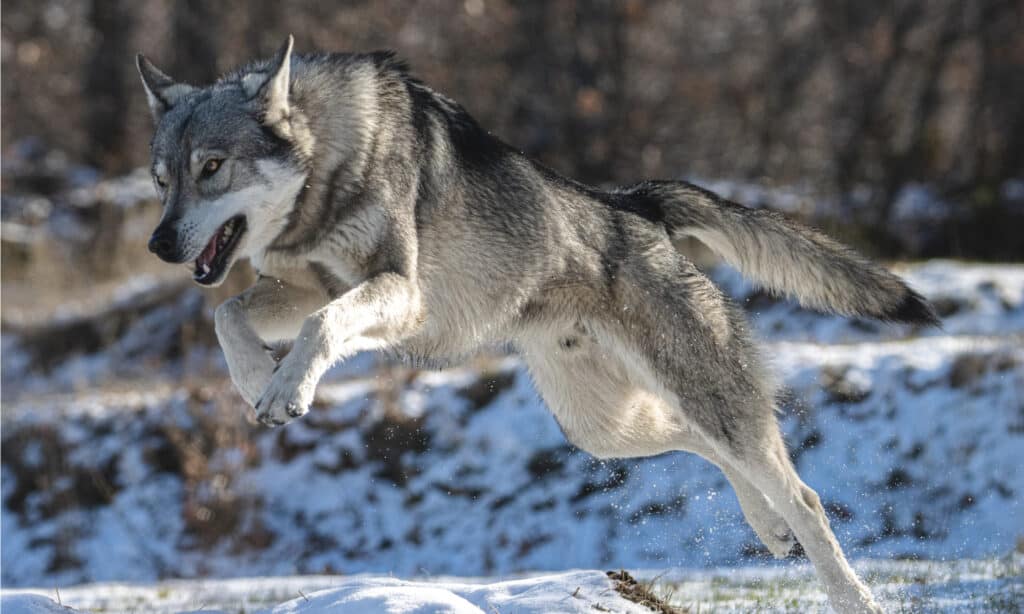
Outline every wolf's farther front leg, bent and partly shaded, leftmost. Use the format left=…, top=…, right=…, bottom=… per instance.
left=214, top=276, right=327, bottom=406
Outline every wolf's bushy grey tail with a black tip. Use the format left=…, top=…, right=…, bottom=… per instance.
left=629, top=181, right=939, bottom=325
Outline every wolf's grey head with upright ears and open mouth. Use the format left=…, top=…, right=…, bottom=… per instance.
left=137, top=37, right=311, bottom=286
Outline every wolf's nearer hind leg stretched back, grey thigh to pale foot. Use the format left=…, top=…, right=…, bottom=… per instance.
left=617, top=251, right=881, bottom=612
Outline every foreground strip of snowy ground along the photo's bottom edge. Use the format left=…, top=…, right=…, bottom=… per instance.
left=0, top=556, right=1024, bottom=614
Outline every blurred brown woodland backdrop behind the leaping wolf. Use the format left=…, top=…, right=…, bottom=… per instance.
left=0, top=0, right=1024, bottom=253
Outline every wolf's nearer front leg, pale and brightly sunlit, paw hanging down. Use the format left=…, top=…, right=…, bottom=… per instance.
left=256, top=272, right=422, bottom=427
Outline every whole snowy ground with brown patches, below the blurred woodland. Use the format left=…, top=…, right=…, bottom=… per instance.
left=0, top=261, right=1024, bottom=614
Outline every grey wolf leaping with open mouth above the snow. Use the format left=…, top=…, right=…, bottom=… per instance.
left=137, top=37, right=938, bottom=612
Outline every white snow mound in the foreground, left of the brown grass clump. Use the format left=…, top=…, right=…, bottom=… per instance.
left=0, top=571, right=650, bottom=614
